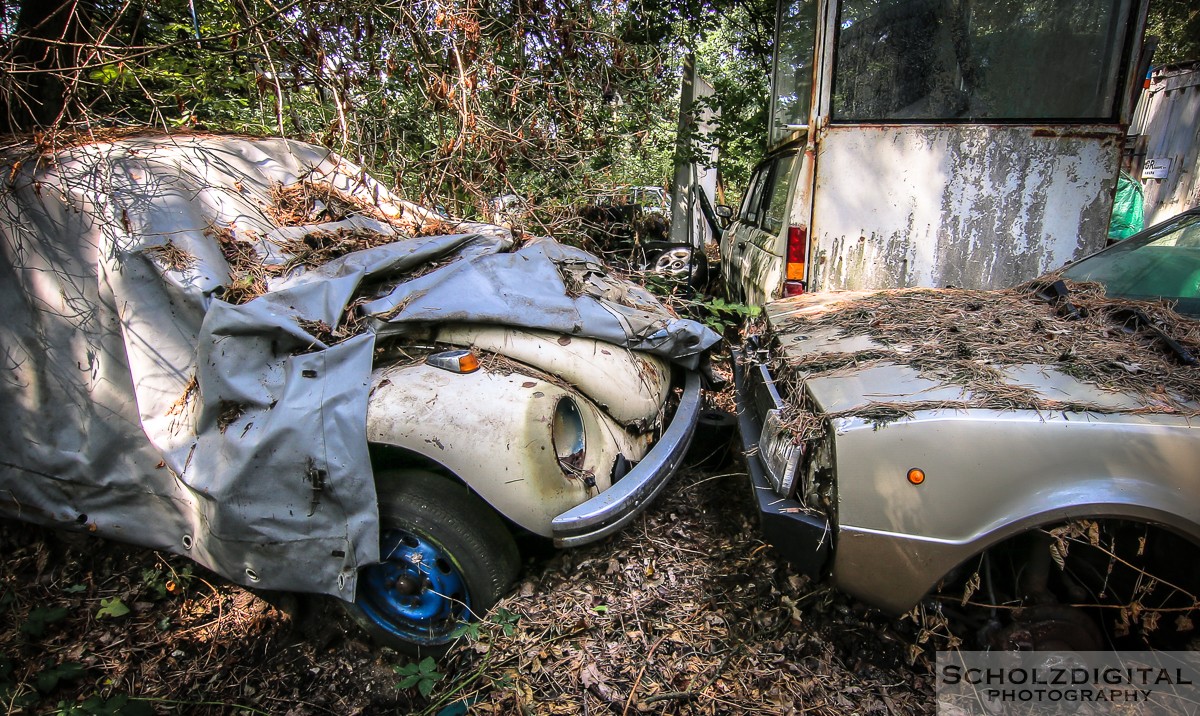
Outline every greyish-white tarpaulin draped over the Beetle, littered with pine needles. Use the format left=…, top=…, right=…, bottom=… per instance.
left=0, top=136, right=718, bottom=598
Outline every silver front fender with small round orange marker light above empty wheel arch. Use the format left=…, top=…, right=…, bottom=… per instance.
left=833, top=410, right=1200, bottom=613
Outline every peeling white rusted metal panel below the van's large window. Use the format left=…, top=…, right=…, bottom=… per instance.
left=810, top=125, right=1121, bottom=290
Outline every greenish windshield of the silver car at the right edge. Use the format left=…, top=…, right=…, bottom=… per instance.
left=1063, top=212, right=1200, bottom=318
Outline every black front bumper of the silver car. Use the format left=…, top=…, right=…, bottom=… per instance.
left=733, top=351, right=833, bottom=577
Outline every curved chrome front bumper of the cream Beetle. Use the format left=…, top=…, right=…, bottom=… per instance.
left=550, top=372, right=701, bottom=547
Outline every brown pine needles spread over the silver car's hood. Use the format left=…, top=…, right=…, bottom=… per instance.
left=776, top=276, right=1200, bottom=419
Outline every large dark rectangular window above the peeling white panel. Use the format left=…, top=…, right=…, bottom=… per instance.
left=832, top=0, right=1132, bottom=121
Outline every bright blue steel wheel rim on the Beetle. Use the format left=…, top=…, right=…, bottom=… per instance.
left=356, top=529, right=470, bottom=645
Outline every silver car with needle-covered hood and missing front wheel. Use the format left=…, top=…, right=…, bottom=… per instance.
left=736, top=210, right=1200, bottom=649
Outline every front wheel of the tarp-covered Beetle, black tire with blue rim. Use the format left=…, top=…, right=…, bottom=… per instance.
left=346, top=470, right=521, bottom=657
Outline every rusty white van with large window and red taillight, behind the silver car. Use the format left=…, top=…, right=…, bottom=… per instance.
left=721, top=0, right=1148, bottom=305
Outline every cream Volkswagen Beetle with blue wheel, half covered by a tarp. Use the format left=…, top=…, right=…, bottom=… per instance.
left=0, top=136, right=718, bottom=652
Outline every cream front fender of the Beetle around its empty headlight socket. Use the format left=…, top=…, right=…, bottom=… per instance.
left=367, top=363, right=649, bottom=537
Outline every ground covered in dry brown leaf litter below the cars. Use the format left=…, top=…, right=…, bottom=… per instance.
left=0, top=352, right=932, bottom=716
